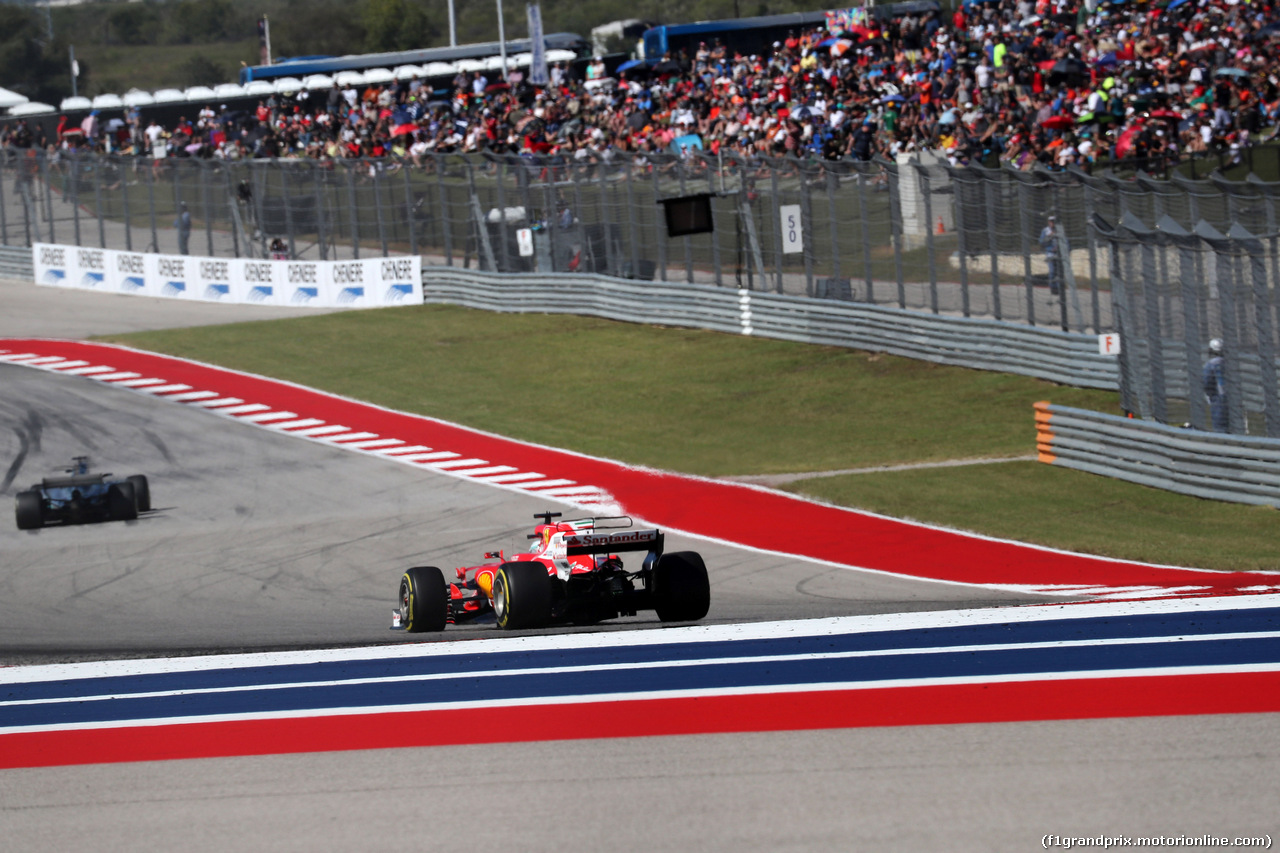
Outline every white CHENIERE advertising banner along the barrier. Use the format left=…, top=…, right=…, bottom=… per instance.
left=32, top=243, right=422, bottom=307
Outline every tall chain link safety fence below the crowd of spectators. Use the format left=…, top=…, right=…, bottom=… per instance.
left=0, top=150, right=1280, bottom=435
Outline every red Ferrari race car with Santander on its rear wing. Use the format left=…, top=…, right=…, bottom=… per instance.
left=392, top=512, right=710, bottom=633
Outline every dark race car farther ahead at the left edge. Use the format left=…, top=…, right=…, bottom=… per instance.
left=15, top=456, right=151, bottom=530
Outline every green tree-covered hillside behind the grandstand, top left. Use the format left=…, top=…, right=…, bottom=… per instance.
left=0, top=0, right=823, bottom=104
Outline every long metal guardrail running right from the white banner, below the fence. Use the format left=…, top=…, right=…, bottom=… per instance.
left=422, top=266, right=1119, bottom=391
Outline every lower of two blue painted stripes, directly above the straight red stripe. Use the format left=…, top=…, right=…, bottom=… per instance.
left=10, top=626, right=1280, bottom=731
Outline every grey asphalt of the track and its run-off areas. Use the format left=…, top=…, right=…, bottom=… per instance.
left=0, top=275, right=1280, bottom=850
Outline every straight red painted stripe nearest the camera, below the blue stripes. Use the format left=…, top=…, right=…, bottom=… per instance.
left=0, top=672, right=1280, bottom=768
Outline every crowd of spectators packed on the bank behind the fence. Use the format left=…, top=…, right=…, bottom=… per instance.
left=5, top=0, right=1280, bottom=169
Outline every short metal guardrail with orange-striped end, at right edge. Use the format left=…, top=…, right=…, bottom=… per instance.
left=1036, top=402, right=1280, bottom=506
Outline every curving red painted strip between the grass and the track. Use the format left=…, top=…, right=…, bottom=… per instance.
left=0, top=339, right=1277, bottom=594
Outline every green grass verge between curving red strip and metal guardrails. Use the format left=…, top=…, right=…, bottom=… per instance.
left=106, top=306, right=1277, bottom=569
